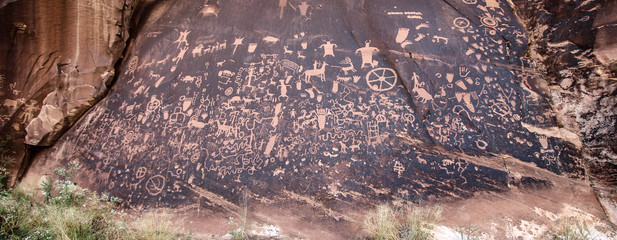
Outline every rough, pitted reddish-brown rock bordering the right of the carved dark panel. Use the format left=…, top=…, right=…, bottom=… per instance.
left=517, top=1, right=617, bottom=222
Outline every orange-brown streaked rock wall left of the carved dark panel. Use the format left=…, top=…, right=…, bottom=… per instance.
left=0, top=0, right=133, bottom=184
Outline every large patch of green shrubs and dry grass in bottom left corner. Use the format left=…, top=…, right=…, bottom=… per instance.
left=0, top=163, right=185, bottom=239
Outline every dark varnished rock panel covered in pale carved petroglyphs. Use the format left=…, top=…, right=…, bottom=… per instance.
left=37, top=0, right=582, bottom=207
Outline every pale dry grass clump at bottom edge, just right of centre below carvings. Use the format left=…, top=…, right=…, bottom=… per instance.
left=364, top=204, right=441, bottom=240
